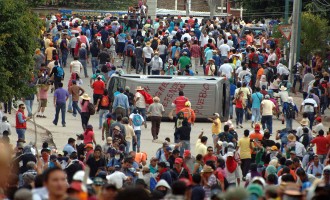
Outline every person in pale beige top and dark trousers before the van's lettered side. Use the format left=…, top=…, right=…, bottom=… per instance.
left=147, top=96, right=165, bottom=140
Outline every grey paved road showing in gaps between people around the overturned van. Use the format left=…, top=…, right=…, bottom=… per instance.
left=9, top=54, right=326, bottom=157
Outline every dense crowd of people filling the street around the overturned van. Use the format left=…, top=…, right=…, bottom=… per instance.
left=0, top=1, right=330, bottom=200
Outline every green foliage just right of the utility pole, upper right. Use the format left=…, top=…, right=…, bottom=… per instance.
left=300, top=12, right=330, bottom=58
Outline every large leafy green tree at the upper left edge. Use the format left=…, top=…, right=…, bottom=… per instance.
left=0, top=0, right=40, bottom=101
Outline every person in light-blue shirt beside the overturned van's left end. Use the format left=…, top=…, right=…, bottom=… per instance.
left=112, top=88, right=130, bottom=117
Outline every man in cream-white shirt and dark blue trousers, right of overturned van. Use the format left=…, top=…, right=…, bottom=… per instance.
left=261, top=94, right=275, bottom=134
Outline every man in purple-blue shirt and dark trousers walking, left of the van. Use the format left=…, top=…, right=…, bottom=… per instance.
left=53, top=82, right=69, bottom=127
